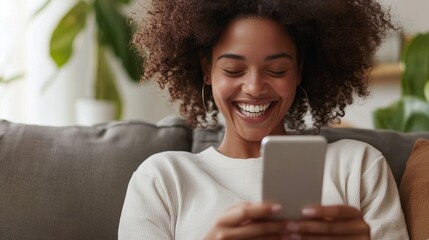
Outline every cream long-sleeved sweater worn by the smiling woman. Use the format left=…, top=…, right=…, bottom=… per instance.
left=118, top=140, right=408, bottom=240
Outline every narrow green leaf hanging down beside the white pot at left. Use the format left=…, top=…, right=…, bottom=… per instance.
left=95, top=46, right=122, bottom=119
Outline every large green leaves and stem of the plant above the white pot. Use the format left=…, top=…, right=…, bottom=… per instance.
left=36, top=0, right=143, bottom=119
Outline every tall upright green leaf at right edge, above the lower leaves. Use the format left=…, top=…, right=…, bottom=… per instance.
left=401, top=32, right=429, bottom=99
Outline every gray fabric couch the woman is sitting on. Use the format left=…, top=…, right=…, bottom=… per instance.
left=0, top=117, right=429, bottom=240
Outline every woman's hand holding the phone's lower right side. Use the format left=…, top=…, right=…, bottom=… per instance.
left=286, top=205, right=370, bottom=240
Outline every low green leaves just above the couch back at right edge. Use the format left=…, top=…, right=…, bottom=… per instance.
left=373, top=96, right=429, bottom=132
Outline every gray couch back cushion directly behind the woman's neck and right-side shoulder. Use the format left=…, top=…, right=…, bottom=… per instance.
left=192, top=126, right=429, bottom=185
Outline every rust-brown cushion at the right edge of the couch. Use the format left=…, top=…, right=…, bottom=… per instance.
left=399, top=139, right=429, bottom=239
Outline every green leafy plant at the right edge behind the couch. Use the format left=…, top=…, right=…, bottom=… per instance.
left=374, top=32, right=429, bottom=132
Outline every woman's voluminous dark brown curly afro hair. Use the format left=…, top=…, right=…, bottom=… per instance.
left=132, top=0, right=394, bottom=131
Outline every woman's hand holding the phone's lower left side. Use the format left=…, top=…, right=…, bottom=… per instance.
left=204, top=202, right=285, bottom=240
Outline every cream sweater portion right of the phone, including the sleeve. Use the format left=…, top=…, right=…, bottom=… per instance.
left=322, top=140, right=408, bottom=240
